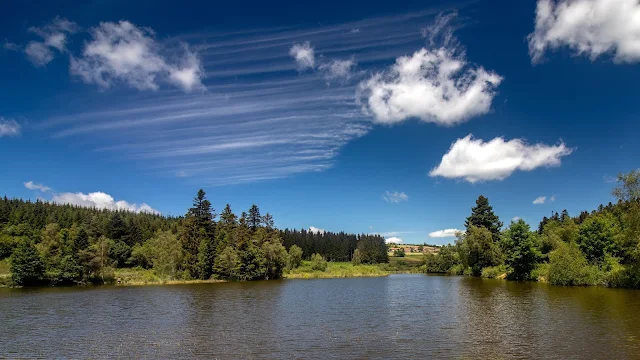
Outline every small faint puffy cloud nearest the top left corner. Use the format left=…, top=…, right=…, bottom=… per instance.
left=24, top=17, right=80, bottom=66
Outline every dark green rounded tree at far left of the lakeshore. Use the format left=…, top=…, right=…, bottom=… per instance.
left=10, top=240, right=44, bottom=286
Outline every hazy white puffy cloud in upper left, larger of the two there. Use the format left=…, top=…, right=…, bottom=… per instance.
left=70, top=21, right=204, bottom=92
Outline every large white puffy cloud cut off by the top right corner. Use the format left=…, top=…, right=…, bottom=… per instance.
left=528, top=0, right=640, bottom=63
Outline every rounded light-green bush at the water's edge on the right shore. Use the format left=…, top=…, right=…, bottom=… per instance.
left=549, top=243, right=600, bottom=285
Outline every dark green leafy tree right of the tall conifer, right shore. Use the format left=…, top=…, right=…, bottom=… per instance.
left=503, top=219, right=540, bottom=280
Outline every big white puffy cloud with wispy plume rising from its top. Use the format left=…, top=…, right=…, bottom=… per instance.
left=357, top=15, right=502, bottom=125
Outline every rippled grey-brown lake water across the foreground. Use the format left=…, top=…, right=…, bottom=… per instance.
left=0, top=275, right=640, bottom=359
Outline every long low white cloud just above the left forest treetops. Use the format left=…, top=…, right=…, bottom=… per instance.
left=52, top=191, right=160, bottom=214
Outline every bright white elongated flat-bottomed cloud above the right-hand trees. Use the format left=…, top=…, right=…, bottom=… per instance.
left=429, top=134, right=573, bottom=183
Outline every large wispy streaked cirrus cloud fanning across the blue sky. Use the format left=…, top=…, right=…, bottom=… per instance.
left=39, top=10, right=458, bottom=186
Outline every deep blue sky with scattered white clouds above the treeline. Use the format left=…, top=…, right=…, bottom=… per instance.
left=0, top=0, right=640, bottom=243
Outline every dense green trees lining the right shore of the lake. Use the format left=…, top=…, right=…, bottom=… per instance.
left=424, top=170, right=640, bottom=288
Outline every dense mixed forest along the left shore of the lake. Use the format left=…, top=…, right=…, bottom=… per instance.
left=0, top=190, right=388, bottom=285
